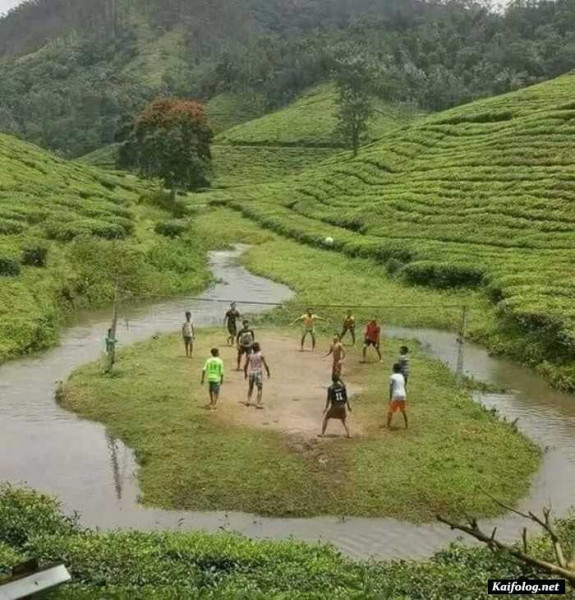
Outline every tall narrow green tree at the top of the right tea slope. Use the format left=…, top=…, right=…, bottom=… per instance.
left=335, top=57, right=373, bottom=157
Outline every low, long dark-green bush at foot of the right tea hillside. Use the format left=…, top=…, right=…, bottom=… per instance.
left=403, top=261, right=483, bottom=289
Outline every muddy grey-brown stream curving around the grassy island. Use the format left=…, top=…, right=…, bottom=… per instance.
left=0, top=250, right=575, bottom=558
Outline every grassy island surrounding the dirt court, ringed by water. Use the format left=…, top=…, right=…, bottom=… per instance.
left=62, top=318, right=539, bottom=522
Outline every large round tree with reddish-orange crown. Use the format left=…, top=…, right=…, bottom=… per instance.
left=118, top=98, right=212, bottom=199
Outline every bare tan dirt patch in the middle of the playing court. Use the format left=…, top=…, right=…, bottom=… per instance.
left=217, top=334, right=361, bottom=437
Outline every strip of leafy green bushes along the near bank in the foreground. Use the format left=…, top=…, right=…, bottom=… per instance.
left=0, top=487, right=575, bottom=600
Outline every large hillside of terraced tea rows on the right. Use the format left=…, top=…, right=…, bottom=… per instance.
left=204, top=75, right=575, bottom=388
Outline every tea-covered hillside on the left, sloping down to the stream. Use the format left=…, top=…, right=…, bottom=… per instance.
left=0, top=134, right=207, bottom=362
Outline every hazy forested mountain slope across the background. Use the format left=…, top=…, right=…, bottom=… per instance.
left=0, top=0, right=575, bottom=156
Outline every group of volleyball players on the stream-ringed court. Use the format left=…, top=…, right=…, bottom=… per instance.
left=182, top=303, right=409, bottom=437
